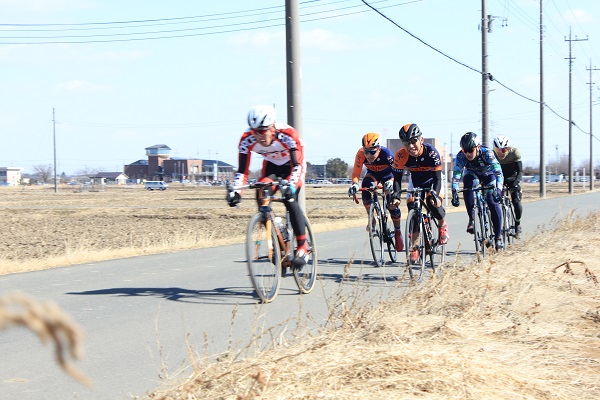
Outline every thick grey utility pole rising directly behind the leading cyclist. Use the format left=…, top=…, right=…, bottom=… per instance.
left=285, top=0, right=306, bottom=211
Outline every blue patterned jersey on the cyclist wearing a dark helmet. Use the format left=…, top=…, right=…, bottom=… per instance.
left=452, top=146, right=504, bottom=190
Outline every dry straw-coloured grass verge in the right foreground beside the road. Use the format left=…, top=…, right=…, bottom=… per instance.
left=149, top=214, right=600, bottom=400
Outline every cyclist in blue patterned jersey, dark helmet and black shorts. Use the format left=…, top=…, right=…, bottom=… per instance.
left=452, top=132, right=504, bottom=250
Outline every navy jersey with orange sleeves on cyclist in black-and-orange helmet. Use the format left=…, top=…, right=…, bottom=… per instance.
left=393, top=143, right=442, bottom=193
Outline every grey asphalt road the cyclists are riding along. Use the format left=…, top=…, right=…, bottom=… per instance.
left=0, top=192, right=600, bottom=399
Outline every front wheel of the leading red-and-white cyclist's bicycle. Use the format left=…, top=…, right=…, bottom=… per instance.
left=246, top=213, right=281, bottom=303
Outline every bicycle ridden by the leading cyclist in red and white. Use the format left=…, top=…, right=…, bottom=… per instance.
left=227, top=180, right=318, bottom=303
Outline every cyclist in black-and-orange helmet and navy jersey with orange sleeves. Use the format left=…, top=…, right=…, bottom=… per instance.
left=393, top=124, right=449, bottom=261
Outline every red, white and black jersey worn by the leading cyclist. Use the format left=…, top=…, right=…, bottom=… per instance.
left=233, top=123, right=306, bottom=188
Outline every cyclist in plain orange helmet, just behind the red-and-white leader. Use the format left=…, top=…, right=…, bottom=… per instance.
left=348, top=132, right=404, bottom=251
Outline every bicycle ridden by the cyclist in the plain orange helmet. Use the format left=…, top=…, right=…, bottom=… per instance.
left=353, top=185, right=397, bottom=267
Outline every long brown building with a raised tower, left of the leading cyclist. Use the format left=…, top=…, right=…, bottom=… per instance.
left=124, top=144, right=235, bottom=182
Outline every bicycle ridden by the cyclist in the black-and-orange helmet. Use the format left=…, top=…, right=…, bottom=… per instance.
left=401, top=187, right=446, bottom=282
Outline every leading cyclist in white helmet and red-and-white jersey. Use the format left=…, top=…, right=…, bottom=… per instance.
left=227, top=105, right=308, bottom=267
